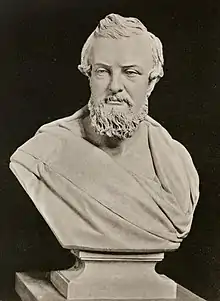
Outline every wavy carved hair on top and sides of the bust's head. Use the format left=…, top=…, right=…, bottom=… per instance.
left=78, top=14, right=164, bottom=96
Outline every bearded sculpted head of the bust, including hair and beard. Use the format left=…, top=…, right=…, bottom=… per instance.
left=79, top=14, right=163, bottom=139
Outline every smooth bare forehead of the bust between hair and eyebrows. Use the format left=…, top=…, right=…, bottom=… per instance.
left=91, top=34, right=153, bottom=66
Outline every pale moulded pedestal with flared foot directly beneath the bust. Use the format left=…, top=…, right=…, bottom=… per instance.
left=50, top=252, right=177, bottom=300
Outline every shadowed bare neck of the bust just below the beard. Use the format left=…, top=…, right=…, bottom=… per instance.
left=83, top=116, right=142, bottom=156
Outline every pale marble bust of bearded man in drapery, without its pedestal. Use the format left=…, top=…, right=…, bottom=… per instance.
left=10, top=14, right=199, bottom=253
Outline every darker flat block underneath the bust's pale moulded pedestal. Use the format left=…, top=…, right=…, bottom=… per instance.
left=15, top=272, right=205, bottom=301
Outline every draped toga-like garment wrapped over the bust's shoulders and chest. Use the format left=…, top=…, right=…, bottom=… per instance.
left=10, top=107, right=199, bottom=252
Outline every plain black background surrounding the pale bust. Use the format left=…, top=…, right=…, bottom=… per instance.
left=0, top=0, right=220, bottom=301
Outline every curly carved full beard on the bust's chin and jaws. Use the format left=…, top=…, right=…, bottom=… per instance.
left=88, top=97, right=148, bottom=139
